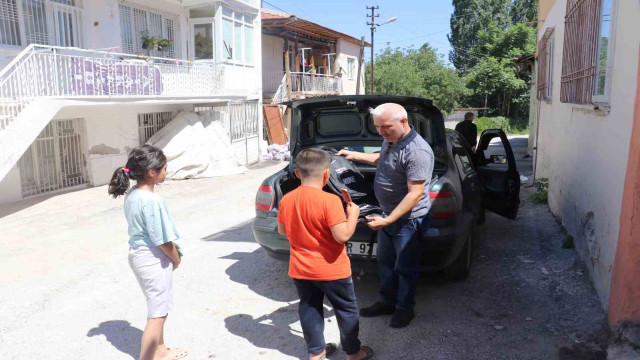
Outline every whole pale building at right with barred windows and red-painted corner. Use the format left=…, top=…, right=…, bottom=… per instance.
left=530, top=0, right=640, bottom=326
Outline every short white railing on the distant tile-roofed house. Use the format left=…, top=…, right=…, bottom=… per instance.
left=273, top=72, right=342, bottom=103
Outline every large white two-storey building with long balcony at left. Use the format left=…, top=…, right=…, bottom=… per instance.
left=0, top=0, right=264, bottom=203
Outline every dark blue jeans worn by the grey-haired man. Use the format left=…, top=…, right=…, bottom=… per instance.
left=377, top=215, right=431, bottom=310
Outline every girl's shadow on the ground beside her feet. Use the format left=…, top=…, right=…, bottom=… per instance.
left=87, top=320, right=142, bottom=359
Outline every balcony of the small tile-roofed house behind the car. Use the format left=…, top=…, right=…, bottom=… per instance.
left=263, top=72, right=342, bottom=103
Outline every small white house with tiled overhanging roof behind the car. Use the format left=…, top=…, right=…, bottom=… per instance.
left=262, top=9, right=371, bottom=103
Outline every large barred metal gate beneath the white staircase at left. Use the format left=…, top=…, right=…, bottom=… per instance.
left=18, top=119, right=86, bottom=197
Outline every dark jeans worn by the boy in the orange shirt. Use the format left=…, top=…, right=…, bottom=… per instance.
left=293, top=277, right=360, bottom=355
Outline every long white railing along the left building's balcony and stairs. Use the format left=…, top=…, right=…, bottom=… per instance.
left=0, top=45, right=225, bottom=130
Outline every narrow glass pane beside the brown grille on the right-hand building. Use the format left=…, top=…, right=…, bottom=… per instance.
left=593, top=0, right=612, bottom=101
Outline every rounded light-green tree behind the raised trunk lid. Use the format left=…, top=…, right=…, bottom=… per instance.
left=365, top=44, right=467, bottom=112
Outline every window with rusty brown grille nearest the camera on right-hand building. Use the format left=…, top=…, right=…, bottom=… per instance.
left=560, top=0, right=612, bottom=104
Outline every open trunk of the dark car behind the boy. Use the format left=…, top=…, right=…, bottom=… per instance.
left=276, top=95, right=447, bottom=248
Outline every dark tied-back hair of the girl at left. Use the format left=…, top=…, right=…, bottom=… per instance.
left=109, top=145, right=167, bottom=198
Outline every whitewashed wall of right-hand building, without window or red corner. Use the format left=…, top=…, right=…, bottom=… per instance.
left=536, top=0, right=640, bottom=308
